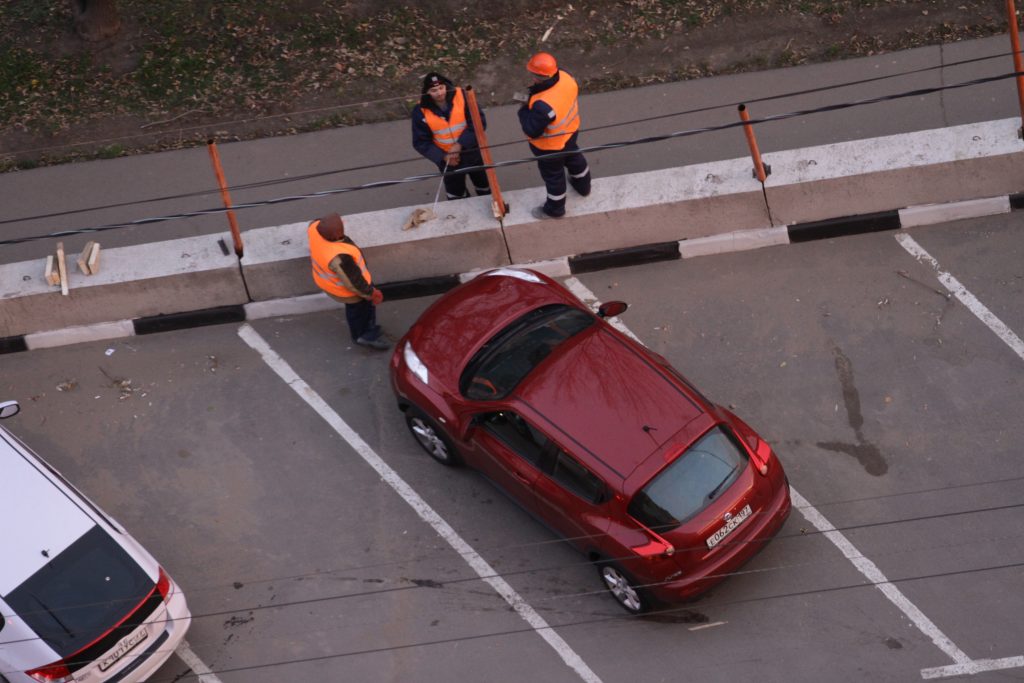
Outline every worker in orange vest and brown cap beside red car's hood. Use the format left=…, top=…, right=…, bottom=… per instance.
left=306, top=213, right=391, bottom=351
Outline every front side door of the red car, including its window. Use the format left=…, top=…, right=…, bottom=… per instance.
left=470, top=411, right=550, bottom=512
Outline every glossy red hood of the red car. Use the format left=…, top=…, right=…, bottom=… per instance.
left=408, top=268, right=580, bottom=391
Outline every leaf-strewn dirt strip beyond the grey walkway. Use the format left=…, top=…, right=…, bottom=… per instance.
left=0, top=0, right=1009, bottom=171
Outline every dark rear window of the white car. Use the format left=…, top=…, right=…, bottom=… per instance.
left=4, top=526, right=154, bottom=657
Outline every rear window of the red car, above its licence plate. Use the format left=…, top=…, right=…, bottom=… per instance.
left=629, top=427, right=748, bottom=531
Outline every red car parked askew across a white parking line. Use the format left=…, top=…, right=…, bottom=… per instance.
left=391, top=268, right=791, bottom=612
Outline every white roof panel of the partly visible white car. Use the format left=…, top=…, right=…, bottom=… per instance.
left=0, top=427, right=95, bottom=595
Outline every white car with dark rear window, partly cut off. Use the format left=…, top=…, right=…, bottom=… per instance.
left=0, top=401, right=191, bottom=683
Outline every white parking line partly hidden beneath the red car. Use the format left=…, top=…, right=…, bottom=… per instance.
left=566, top=278, right=980, bottom=677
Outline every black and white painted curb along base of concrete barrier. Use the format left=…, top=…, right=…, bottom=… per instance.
left=0, top=193, right=1024, bottom=354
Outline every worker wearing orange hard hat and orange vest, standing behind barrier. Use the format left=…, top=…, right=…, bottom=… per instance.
left=519, top=52, right=591, bottom=218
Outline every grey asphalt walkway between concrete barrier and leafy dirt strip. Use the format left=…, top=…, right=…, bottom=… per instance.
left=0, top=36, right=1019, bottom=263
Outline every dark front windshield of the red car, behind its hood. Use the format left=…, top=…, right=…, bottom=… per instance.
left=459, top=304, right=595, bottom=400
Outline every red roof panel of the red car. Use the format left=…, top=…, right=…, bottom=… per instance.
left=515, top=322, right=707, bottom=480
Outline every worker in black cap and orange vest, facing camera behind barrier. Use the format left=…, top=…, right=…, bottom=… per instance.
left=413, top=72, right=490, bottom=200
